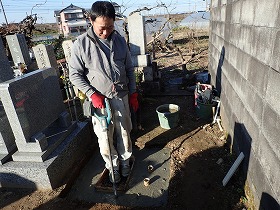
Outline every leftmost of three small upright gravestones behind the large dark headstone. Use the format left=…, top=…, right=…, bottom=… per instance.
left=6, top=34, right=31, bottom=66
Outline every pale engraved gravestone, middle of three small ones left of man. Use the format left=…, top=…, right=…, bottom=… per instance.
left=32, top=44, right=59, bottom=75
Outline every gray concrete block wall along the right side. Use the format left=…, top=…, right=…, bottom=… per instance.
left=209, top=0, right=280, bottom=209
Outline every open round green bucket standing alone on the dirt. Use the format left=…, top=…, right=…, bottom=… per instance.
left=156, top=104, right=180, bottom=129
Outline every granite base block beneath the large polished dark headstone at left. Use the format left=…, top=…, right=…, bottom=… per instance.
left=0, top=122, right=97, bottom=189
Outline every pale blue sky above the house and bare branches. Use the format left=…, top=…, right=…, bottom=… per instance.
left=0, top=0, right=210, bottom=24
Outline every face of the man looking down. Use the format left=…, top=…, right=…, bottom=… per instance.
left=91, top=17, right=114, bottom=39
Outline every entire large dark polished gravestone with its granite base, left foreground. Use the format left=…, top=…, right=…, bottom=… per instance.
left=0, top=68, right=93, bottom=189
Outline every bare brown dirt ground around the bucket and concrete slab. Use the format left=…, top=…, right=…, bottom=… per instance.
left=0, top=17, right=254, bottom=210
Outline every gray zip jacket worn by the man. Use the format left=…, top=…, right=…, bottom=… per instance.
left=69, top=27, right=136, bottom=98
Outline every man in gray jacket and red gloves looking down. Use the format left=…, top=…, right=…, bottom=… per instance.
left=69, top=1, right=138, bottom=183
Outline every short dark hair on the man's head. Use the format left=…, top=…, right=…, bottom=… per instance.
left=90, top=1, right=116, bottom=21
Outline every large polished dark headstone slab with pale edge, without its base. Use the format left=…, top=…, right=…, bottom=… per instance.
left=0, top=68, right=66, bottom=152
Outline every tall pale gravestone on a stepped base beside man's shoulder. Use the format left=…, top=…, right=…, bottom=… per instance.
left=128, top=12, right=153, bottom=81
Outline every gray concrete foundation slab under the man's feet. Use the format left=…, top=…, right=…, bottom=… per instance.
left=68, top=148, right=170, bottom=207
